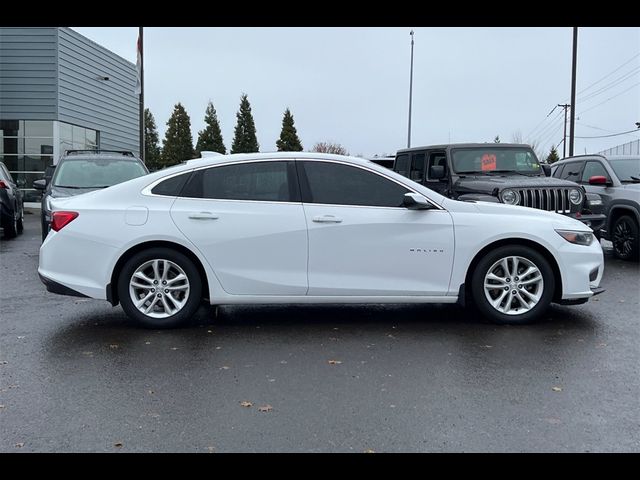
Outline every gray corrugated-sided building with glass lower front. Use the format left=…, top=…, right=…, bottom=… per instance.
left=0, top=27, right=140, bottom=202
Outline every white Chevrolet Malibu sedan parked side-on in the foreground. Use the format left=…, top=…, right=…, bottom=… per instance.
left=38, top=152, right=604, bottom=328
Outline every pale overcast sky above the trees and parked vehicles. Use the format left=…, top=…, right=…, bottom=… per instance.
left=73, top=27, right=640, bottom=156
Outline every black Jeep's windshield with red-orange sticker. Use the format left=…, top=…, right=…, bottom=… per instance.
left=451, top=146, right=542, bottom=175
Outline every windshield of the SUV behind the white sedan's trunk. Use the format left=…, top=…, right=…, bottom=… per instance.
left=53, top=158, right=147, bottom=188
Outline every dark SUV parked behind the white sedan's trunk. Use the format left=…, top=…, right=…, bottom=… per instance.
left=33, top=150, right=149, bottom=241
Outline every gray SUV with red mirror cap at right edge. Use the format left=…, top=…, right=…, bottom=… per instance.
left=552, top=155, right=640, bottom=260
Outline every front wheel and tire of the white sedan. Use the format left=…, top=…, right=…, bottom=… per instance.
left=471, top=245, right=555, bottom=325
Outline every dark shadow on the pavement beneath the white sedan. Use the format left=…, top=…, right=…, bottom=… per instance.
left=45, top=304, right=599, bottom=359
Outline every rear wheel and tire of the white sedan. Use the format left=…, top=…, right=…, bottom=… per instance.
left=117, top=248, right=202, bottom=328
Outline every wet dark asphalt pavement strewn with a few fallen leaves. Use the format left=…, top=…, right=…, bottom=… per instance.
left=0, top=215, right=640, bottom=453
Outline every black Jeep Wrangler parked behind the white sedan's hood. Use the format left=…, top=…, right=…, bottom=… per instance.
left=393, top=143, right=606, bottom=235
